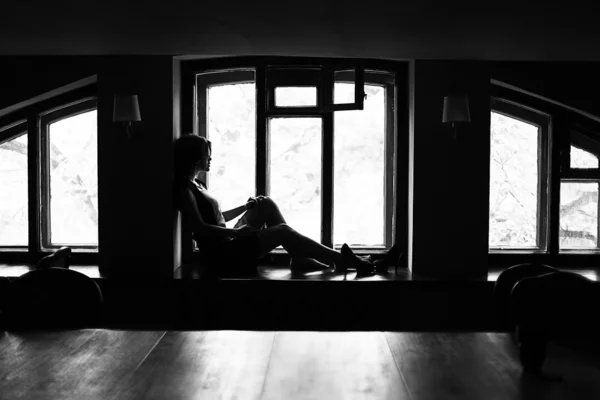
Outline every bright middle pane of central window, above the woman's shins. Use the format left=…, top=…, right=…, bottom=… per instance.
left=269, top=118, right=322, bottom=242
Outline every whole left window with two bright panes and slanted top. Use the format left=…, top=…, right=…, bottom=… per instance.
left=0, top=87, right=98, bottom=263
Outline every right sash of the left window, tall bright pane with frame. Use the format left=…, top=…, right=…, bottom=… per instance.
left=41, top=100, right=98, bottom=248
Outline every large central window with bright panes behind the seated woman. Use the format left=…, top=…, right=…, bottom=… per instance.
left=184, top=58, right=396, bottom=258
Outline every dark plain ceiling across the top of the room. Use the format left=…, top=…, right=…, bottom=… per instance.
left=0, top=0, right=600, bottom=61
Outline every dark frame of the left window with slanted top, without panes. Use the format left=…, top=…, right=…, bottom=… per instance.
left=0, top=83, right=98, bottom=265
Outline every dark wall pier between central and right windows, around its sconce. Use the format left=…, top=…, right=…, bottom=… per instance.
left=409, top=60, right=490, bottom=277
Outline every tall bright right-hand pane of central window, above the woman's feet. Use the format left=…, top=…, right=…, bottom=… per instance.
left=333, top=83, right=386, bottom=246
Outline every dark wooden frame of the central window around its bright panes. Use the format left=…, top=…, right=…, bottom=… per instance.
left=181, top=56, right=409, bottom=262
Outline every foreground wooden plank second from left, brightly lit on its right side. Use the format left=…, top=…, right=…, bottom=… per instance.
left=113, top=331, right=274, bottom=400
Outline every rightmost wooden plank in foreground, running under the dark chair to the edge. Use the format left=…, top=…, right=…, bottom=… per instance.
left=385, top=332, right=600, bottom=400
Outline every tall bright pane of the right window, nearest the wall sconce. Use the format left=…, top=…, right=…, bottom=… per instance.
left=489, top=112, right=539, bottom=248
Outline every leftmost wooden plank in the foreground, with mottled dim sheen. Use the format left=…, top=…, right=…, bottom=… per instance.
left=0, top=329, right=164, bottom=400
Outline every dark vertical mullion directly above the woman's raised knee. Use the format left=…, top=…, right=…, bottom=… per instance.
left=255, top=65, right=269, bottom=195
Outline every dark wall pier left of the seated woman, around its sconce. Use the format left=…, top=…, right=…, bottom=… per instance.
left=98, top=56, right=174, bottom=276
